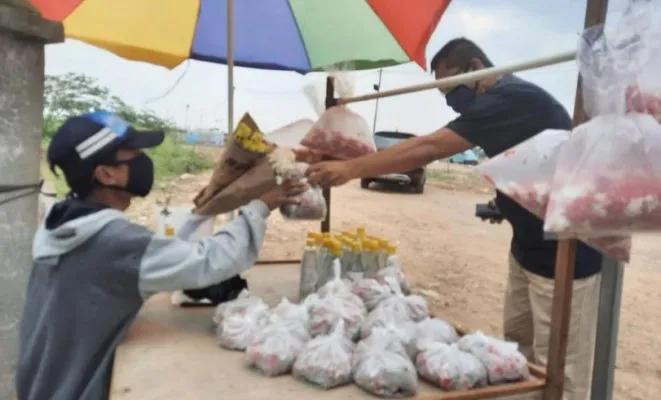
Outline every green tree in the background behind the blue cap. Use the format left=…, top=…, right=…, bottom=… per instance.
left=44, top=73, right=176, bottom=137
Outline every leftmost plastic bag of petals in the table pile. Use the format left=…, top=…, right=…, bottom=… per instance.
left=216, top=304, right=268, bottom=350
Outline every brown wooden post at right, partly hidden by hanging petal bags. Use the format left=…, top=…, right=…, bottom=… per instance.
left=543, top=0, right=608, bottom=400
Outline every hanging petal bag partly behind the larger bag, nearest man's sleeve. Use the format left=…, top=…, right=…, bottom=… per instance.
left=477, top=129, right=631, bottom=262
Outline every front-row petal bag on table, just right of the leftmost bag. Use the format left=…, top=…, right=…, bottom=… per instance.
left=245, top=316, right=310, bottom=376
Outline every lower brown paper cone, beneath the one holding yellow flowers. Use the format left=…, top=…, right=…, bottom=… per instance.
left=195, top=157, right=277, bottom=215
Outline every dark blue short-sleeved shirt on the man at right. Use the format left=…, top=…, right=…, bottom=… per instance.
left=447, top=75, right=602, bottom=279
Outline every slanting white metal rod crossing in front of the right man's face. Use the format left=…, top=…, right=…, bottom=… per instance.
left=337, top=50, right=576, bottom=104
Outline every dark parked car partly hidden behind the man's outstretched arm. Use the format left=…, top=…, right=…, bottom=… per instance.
left=360, top=131, right=427, bottom=193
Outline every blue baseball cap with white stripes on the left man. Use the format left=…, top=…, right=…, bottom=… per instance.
left=47, top=111, right=165, bottom=195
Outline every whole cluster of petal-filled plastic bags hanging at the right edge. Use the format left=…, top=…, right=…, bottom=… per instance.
left=480, top=2, right=661, bottom=261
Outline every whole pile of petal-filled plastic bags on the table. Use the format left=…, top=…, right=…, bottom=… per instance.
left=213, top=238, right=529, bottom=397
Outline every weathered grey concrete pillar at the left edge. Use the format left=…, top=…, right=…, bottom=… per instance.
left=0, top=5, right=63, bottom=400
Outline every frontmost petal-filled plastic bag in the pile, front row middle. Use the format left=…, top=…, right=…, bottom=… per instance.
left=353, top=331, right=418, bottom=397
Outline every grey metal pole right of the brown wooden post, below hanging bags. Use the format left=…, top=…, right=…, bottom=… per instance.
left=590, top=257, right=624, bottom=400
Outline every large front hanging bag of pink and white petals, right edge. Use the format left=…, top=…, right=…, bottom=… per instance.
left=544, top=113, right=661, bottom=237
